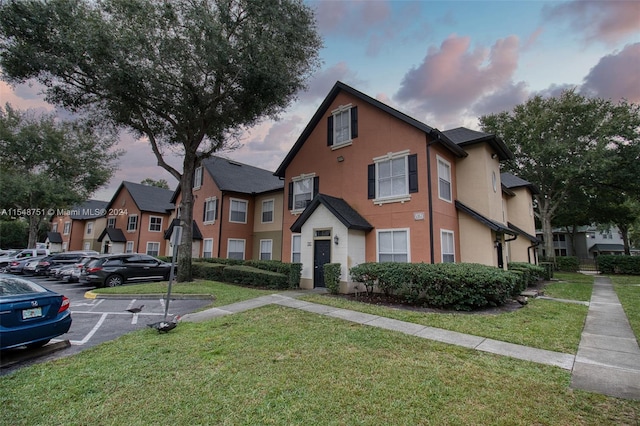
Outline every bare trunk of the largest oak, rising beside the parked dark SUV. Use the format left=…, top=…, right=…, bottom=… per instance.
left=176, top=153, right=197, bottom=282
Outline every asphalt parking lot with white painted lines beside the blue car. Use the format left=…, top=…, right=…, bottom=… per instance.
left=0, top=277, right=211, bottom=375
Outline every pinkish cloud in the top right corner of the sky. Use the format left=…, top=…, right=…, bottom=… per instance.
left=543, top=0, right=640, bottom=43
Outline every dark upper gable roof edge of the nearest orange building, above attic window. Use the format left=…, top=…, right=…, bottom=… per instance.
left=274, top=81, right=467, bottom=177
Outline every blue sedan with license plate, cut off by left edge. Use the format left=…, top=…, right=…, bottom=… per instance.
left=0, top=274, right=71, bottom=350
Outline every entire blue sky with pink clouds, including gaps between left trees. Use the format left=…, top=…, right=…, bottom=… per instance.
left=0, top=0, right=640, bottom=201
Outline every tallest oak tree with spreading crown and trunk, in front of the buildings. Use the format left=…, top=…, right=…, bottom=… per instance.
left=0, top=0, right=322, bottom=281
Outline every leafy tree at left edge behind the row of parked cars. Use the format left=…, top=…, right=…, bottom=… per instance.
left=0, top=104, right=118, bottom=248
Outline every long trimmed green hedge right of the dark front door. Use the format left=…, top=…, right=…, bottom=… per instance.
left=350, top=263, right=519, bottom=310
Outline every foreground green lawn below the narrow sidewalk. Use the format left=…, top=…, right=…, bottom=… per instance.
left=0, top=306, right=640, bottom=425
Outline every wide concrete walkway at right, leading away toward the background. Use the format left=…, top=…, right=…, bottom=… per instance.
left=571, top=277, right=640, bottom=400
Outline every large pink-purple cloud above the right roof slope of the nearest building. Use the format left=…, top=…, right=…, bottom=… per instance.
left=394, top=35, right=521, bottom=121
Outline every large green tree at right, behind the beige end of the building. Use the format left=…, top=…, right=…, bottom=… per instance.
left=480, top=90, right=640, bottom=259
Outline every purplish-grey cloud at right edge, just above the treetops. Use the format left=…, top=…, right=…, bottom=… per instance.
left=581, top=42, right=640, bottom=103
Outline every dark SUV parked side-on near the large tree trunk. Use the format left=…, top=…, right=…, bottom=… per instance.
left=80, top=253, right=171, bottom=287
